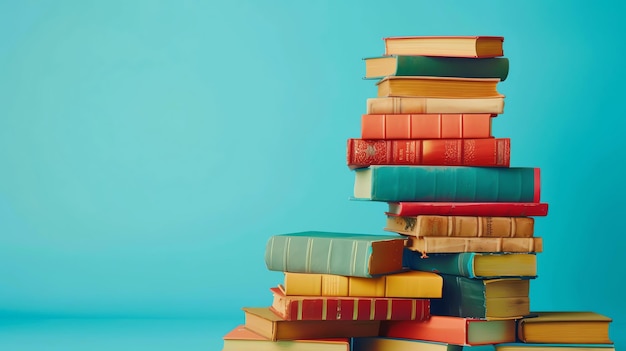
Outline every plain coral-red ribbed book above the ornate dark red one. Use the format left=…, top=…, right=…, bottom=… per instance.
left=361, top=113, right=493, bottom=139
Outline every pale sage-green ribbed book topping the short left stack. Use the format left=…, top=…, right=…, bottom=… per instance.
left=265, top=231, right=406, bottom=278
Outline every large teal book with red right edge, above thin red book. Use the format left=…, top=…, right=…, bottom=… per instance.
left=353, top=165, right=541, bottom=202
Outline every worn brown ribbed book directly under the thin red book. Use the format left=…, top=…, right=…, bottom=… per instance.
left=384, top=215, right=535, bottom=238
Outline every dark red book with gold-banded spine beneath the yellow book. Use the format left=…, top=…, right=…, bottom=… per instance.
left=270, top=288, right=430, bottom=321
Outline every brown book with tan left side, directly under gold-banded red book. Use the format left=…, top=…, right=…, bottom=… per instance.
left=243, top=307, right=380, bottom=341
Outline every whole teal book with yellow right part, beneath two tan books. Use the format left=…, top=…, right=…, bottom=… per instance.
left=403, top=250, right=537, bottom=279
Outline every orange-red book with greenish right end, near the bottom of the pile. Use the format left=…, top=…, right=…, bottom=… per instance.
left=380, top=316, right=516, bottom=346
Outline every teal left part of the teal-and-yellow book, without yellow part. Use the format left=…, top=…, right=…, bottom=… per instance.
left=403, top=250, right=477, bottom=278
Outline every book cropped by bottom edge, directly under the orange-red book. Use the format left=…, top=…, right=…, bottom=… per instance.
left=352, top=337, right=463, bottom=351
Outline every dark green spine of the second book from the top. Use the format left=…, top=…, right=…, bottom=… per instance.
left=395, top=56, right=509, bottom=81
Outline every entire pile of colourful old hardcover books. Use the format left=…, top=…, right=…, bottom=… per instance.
left=223, top=36, right=614, bottom=351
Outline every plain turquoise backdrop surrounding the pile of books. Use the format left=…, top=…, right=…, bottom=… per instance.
left=0, top=0, right=626, bottom=350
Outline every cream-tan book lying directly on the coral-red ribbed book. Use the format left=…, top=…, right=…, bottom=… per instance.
left=366, top=97, right=504, bottom=115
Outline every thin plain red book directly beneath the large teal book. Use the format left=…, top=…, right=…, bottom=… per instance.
left=386, top=202, right=548, bottom=217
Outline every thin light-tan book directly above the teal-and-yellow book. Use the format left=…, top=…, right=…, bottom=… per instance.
left=407, top=236, right=543, bottom=255
